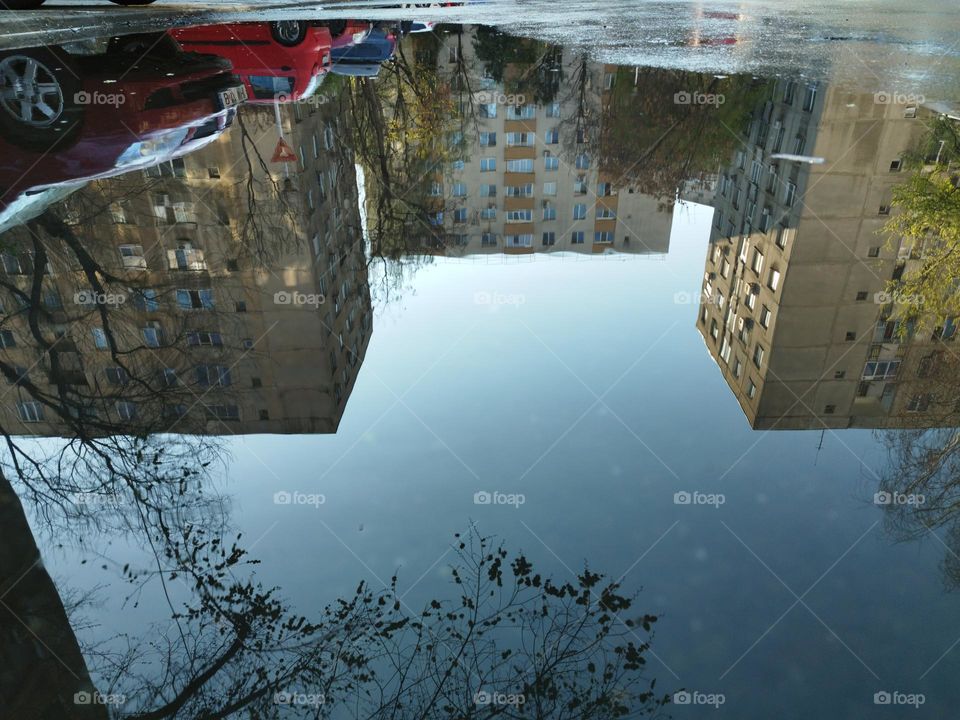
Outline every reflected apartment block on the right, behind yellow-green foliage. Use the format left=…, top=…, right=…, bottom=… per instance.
left=697, top=82, right=954, bottom=430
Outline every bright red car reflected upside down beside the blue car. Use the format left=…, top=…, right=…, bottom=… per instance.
left=169, top=20, right=369, bottom=103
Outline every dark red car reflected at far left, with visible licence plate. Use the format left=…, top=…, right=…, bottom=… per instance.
left=0, top=41, right=246, bottom=230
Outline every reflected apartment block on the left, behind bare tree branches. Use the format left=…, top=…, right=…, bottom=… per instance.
left=0, top=98, right=372, bottom=436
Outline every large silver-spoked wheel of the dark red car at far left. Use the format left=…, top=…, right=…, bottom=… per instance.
left=0, top=48, right=84, bottom=151
